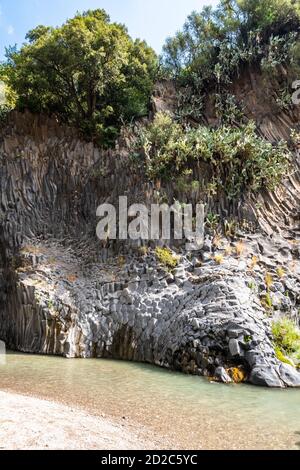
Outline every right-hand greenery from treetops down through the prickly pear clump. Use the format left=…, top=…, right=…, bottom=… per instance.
left=129, top=0, right=300, bottom=195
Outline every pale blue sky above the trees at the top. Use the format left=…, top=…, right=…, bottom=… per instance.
left=0, top=0, right=218, bottom=59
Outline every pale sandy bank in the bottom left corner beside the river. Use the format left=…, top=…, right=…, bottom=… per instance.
left=0, top=391, right=158, bottom=450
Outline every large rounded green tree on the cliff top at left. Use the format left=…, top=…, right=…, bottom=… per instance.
left=1, top=9, right=157, bottom=145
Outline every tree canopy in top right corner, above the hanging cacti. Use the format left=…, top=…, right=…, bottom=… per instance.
left=163, top=0, right=300, bottom=75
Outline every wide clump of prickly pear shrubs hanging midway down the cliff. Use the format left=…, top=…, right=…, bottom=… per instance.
left=135, top=113, right=290, bottom=198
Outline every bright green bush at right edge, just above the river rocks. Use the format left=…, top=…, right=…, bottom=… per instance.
left=272, top=318, right=300, bottom=366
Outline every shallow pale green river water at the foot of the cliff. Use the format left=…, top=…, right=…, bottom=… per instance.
left=0, top=353, right=300, bottom=449
